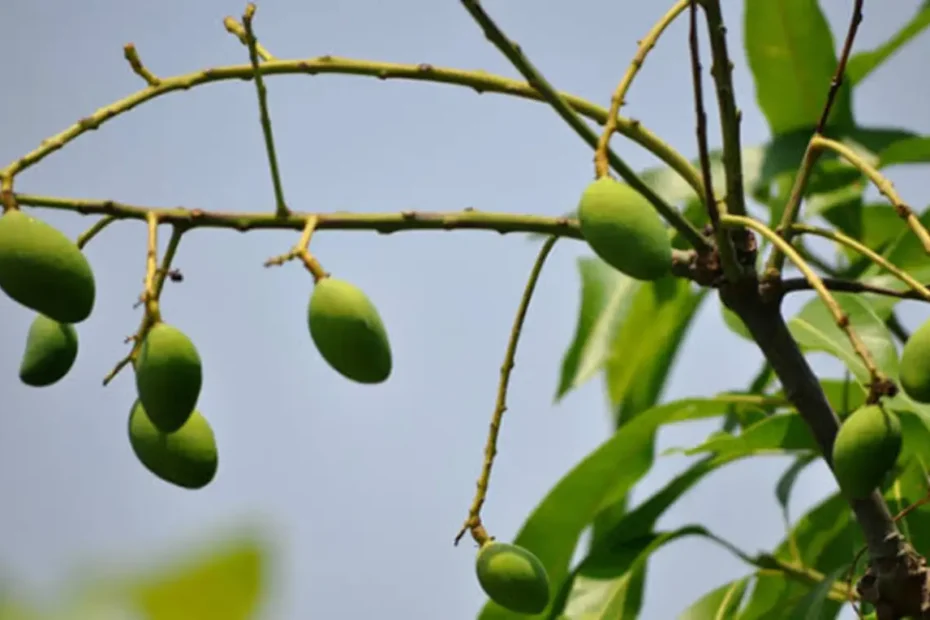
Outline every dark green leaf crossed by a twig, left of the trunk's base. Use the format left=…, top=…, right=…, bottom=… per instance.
left=738, top=494, right=862, bottom=620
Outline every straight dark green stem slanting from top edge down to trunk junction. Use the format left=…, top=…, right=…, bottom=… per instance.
left=461, top=0, right=712, bottom=253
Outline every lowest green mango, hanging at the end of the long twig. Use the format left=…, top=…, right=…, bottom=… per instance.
left=475, top=540, right=549, bottom=614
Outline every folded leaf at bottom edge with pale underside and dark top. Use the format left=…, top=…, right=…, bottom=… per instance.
left=553, top=525, right=750, bottom=620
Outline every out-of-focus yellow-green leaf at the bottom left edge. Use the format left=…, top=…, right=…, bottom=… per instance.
left=131, top=538, right=265, bottom=620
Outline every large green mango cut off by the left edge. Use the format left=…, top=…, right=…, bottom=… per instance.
left=0, top=209, right=97, bottom=323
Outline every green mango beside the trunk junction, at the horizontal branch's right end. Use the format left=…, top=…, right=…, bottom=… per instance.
left=578, top=176, right=672, bottom=280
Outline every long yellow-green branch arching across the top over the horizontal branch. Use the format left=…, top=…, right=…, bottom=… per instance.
left=0, top=57, right=704, bottom=211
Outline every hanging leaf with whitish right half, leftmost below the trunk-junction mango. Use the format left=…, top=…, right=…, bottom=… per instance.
left=555, top=258, right=641, bottom=401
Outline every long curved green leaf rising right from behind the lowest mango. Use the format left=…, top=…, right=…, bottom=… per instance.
left=478, top=398, right=730, bottom=620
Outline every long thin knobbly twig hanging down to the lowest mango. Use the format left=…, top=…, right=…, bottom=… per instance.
left=455, top=237, right=558, bottom=545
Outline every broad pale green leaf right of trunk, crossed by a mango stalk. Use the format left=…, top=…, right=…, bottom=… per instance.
left=788, top=293, right=898, bottom=384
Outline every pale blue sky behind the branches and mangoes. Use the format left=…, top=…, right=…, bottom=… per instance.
left=0, top=0, right=930, bottom=620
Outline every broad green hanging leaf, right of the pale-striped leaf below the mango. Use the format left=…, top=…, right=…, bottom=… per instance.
left=604, top=277, right=707, bottom=423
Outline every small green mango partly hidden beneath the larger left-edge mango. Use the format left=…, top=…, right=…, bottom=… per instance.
left=19, top=314, right=78, bottom=387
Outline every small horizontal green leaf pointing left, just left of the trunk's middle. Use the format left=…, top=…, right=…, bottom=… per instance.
left=685, top=413, right=817, bottom=460
